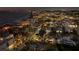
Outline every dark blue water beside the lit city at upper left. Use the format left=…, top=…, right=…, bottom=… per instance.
left=0, top=12, right=30, bottom=25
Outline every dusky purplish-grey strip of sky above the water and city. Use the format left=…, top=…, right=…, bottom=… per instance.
left=0, top=7, right=79, bottom=11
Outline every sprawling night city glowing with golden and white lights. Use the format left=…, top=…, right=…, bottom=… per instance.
left=0, top=10, right=79, bottom=51
